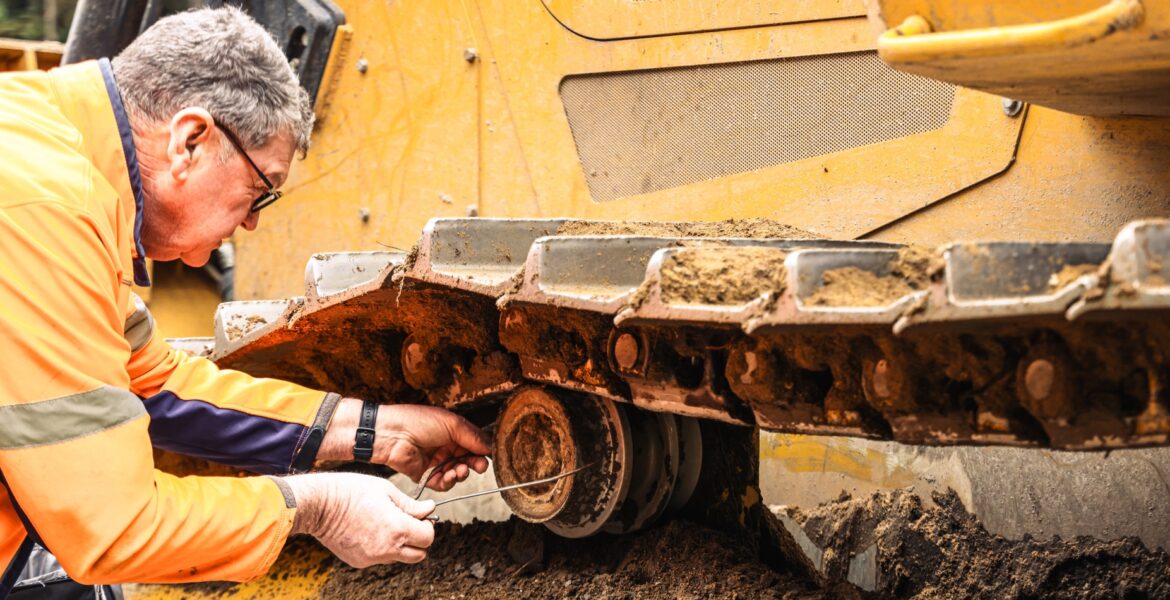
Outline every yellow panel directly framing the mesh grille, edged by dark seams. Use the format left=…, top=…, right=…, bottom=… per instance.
left=470, top=11, right=1021, bottom=237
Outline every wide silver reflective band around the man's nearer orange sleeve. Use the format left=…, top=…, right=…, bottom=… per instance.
left=0, top=386, right=146, bottom=450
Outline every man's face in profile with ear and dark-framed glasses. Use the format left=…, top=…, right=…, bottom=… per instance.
left=142, top=108, right=295, bottom=267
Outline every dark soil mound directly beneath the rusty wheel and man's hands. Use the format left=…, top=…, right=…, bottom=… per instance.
left=321, top=518, right=825, bottom=599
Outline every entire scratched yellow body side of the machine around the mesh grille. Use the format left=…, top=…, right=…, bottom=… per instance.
left=238, top=0, right=1170, bottom=298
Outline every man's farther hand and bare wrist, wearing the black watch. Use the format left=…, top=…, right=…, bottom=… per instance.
left=317, top=398, right=491, bottom=491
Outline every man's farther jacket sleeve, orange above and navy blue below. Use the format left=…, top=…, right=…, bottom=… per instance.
left=124, top=295, right=339, bottom=474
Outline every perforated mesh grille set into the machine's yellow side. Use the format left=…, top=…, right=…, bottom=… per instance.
left=560, top=51, right=955, bottom=200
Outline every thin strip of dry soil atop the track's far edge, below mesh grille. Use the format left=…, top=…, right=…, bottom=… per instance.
left=557, top=219, right=825, bottom=240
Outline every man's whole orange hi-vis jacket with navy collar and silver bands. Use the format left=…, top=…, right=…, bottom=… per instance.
left=0, top=60, right=337, bottom=584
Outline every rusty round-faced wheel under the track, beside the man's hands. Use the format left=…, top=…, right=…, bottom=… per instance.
left=493, top=388, right=633, bottom=538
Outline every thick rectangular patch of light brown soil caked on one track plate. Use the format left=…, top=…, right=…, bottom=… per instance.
left=660, top=248, right=786, bottom=304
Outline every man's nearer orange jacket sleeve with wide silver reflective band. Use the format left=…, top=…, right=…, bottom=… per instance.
left=0, top=201, right=295, bottom=584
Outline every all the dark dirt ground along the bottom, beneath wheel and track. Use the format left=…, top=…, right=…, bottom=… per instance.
left=300, top=491, right=1170, bottom=599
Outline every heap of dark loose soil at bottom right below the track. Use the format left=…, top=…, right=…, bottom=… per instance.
left=790, top=490, right=1170, bottom=599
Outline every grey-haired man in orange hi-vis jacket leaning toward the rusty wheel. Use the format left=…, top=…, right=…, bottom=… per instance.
left=0, top=8, right=489, bottom=596
